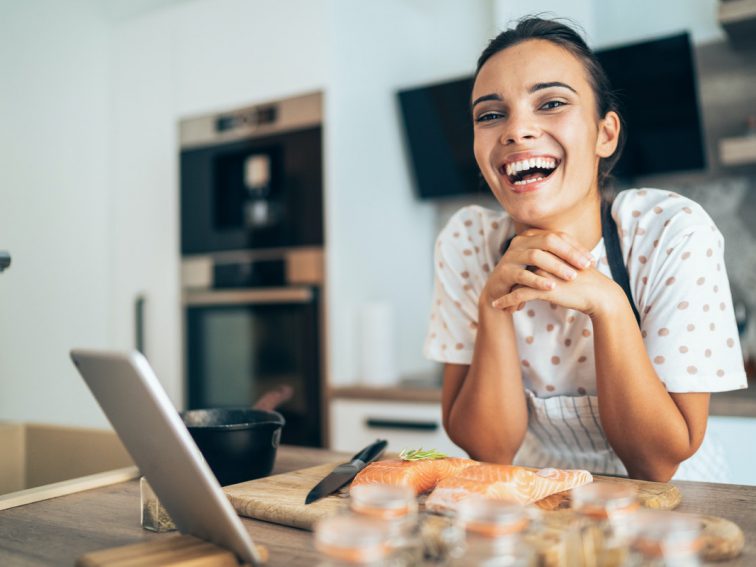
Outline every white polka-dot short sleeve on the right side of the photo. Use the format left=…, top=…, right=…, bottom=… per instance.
left=636, top=215, right=747, bottom=393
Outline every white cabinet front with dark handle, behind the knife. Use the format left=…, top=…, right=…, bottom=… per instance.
left=330, top=399, right=467, bottom=457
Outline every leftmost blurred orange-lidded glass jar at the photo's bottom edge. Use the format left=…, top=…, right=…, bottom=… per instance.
left=314, top=514, right=393, bottom=567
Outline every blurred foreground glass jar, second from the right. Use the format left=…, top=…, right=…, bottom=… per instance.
left=565, top=483, right=640, bottom=567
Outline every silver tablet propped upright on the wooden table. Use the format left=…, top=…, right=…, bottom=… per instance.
left=71, top=349, right=260, bottom=565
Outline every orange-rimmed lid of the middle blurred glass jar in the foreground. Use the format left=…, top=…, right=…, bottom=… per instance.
left=456, top=496, right=530, bottom=538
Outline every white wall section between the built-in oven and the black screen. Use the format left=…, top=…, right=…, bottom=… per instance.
left=326, top=0, right=491, bottom=383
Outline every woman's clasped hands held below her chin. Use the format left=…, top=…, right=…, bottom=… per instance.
left=484, top=228, right=614, bottom=315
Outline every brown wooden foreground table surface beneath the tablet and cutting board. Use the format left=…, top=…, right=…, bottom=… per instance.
left=0, top=447, right=756, bottom=567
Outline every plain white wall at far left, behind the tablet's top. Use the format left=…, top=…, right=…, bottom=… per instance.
left=0, top=0, right=112, bottom=423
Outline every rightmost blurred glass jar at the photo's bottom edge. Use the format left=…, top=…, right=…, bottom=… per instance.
left=628, top=510, right=702, bottom=567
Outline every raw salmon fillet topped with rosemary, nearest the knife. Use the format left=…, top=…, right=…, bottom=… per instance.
left=352, top=457, right=478, bottom=494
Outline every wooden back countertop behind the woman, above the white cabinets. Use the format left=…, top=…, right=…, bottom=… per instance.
left=330, top=380, right=756, bottom=417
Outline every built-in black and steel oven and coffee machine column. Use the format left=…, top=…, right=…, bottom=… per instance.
left=180, top=94, right=326, bottom=446
